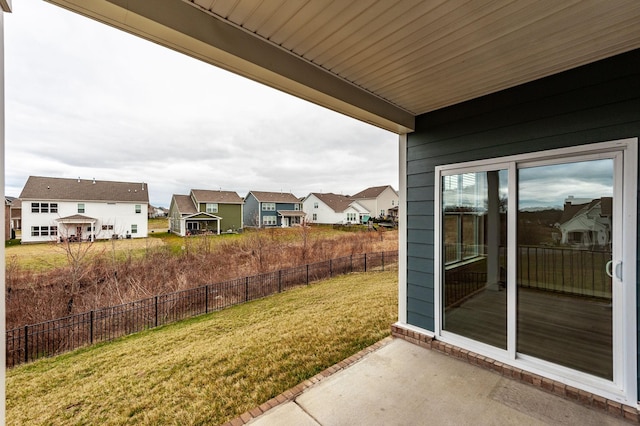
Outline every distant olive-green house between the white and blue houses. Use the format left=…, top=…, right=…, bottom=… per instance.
left=169, top=189, right=243, bottom=237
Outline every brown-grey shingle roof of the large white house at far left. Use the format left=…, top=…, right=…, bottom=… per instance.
left=19, top=176, right=149, bottom=203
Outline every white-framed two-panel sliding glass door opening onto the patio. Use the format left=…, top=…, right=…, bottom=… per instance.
left=436, top=140, right=637, bottom=397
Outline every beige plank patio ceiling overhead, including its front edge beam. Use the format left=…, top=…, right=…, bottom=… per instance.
left=43, top=0, right=640, bottom=133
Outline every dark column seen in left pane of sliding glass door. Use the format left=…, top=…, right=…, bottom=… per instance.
left=488, top=171, right=500, bottom=290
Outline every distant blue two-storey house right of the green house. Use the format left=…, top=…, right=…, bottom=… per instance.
left=243, top=191, right=305, bottom=228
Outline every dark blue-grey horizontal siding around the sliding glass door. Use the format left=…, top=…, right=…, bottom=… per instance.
left=406, top=50, right=640, bottom=370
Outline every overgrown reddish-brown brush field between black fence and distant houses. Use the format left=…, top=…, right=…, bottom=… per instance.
left=5, top=227, right=398, bottom=329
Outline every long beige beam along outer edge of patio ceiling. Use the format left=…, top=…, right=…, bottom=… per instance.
left=47, top=0, right=415, bottom=134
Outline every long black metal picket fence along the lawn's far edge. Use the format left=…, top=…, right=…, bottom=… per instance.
left=6, top=251, right=398, bottom=367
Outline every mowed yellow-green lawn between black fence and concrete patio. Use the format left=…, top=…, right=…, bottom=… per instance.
left=6, top=271, right=397, bottom=425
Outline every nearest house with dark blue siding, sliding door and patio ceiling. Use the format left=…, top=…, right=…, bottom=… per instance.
left=21, top=0, right=640, bottom=419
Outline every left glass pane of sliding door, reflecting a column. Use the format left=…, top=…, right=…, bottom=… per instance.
left=442, top=170, right=507, bottom=349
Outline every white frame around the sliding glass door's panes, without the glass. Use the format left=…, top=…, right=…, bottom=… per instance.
left=432, top=138, right=638, bottom=406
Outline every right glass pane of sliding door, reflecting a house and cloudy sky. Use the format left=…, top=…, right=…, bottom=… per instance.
left=517, top=159, right=613, bottom=380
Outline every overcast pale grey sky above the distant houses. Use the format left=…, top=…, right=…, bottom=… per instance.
left=5, top=0, right=398, bottom=207
